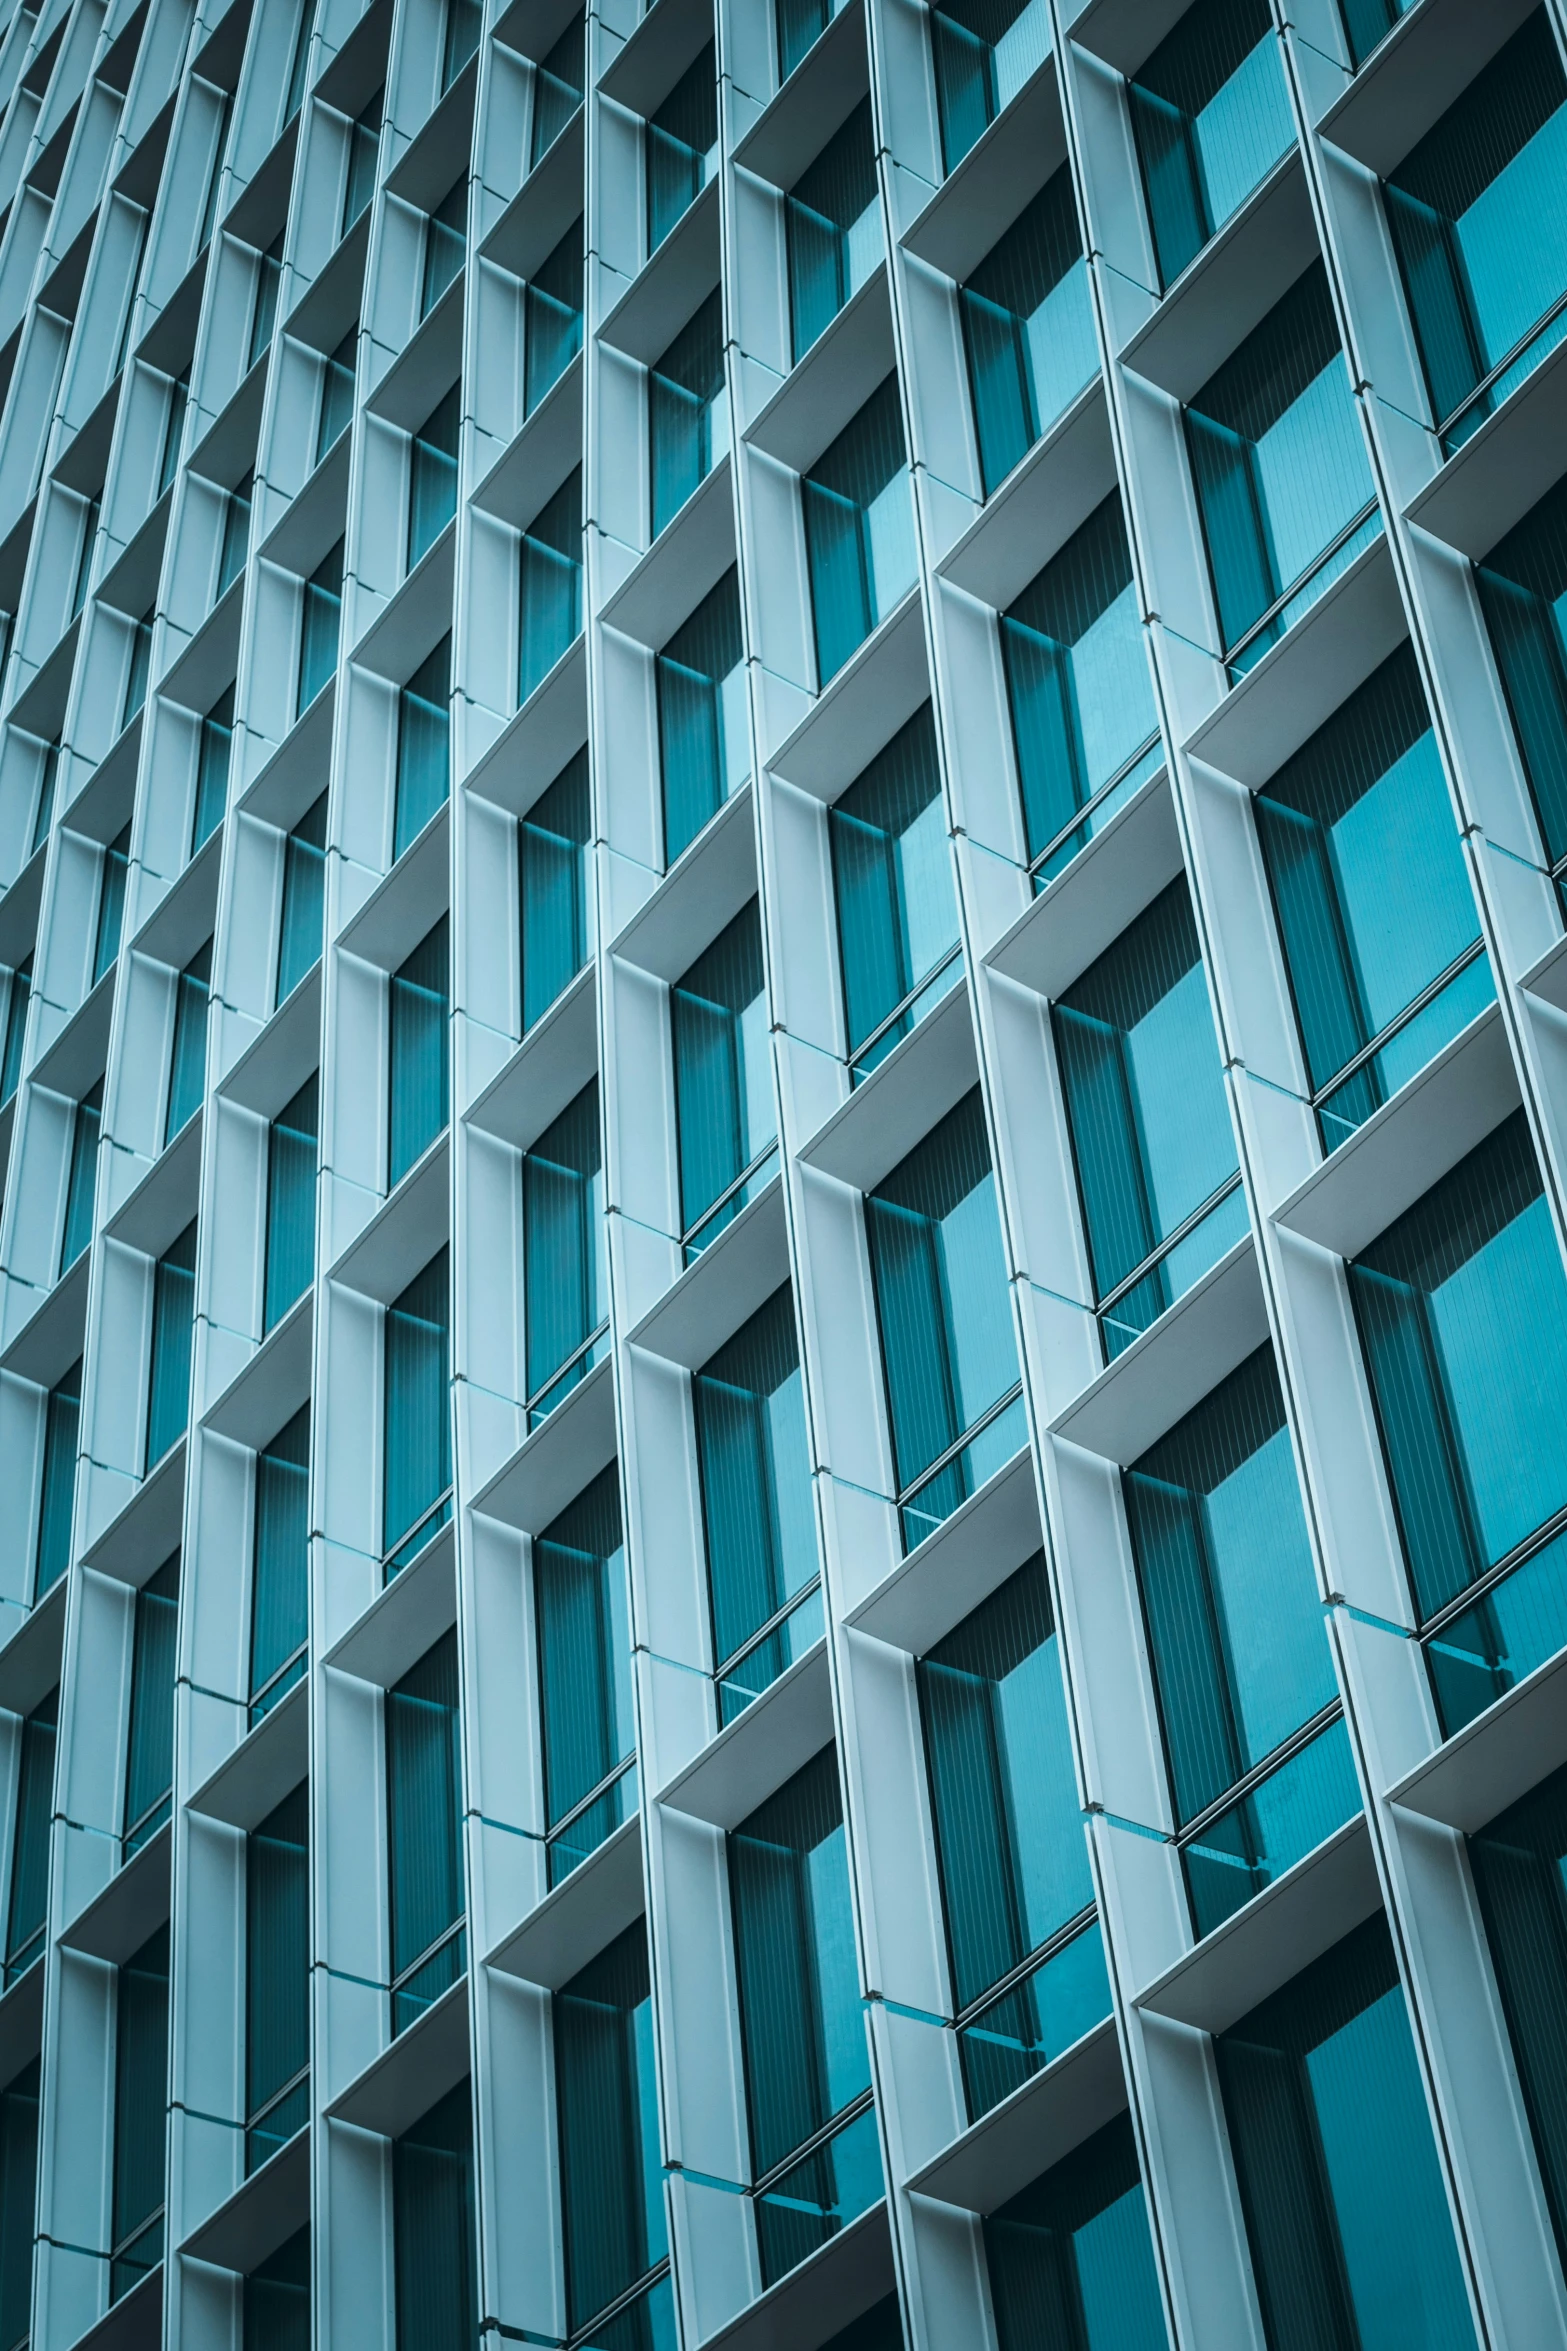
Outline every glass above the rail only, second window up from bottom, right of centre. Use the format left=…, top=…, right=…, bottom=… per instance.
left=916, top=1552, right=1095, bottom=2003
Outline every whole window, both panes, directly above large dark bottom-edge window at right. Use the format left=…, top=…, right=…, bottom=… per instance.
left=1121, top=1345, right=1360, bottom=1935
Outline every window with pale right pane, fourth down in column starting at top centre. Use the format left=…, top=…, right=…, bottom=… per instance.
left=827, top=703, right=963, bottom=1079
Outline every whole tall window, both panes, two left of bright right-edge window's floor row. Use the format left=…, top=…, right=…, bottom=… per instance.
left=916, top=1552, right=1111, bottom=2123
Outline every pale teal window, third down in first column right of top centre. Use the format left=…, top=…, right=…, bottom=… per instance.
left=1001, top=494, right=1158, bottom=860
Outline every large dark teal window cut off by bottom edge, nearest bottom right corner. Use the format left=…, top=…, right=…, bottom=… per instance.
left=1215, top=1914, right=1475, bottom=2351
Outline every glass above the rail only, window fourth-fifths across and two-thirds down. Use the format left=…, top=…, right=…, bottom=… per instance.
left=1121, top=1345, right=1337, bottom=1822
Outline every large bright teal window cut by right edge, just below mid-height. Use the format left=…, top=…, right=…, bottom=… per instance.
left=1349, top=1110, right=1567, bottom=1737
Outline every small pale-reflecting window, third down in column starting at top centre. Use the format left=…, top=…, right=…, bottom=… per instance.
left=799, top=374, right=919, bottom=686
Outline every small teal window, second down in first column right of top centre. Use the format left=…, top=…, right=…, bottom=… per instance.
left=959, top=165, right=1099, bottom=494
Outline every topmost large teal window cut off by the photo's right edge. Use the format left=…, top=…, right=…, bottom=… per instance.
left=1384, top=7, right=1567, bottom=451
